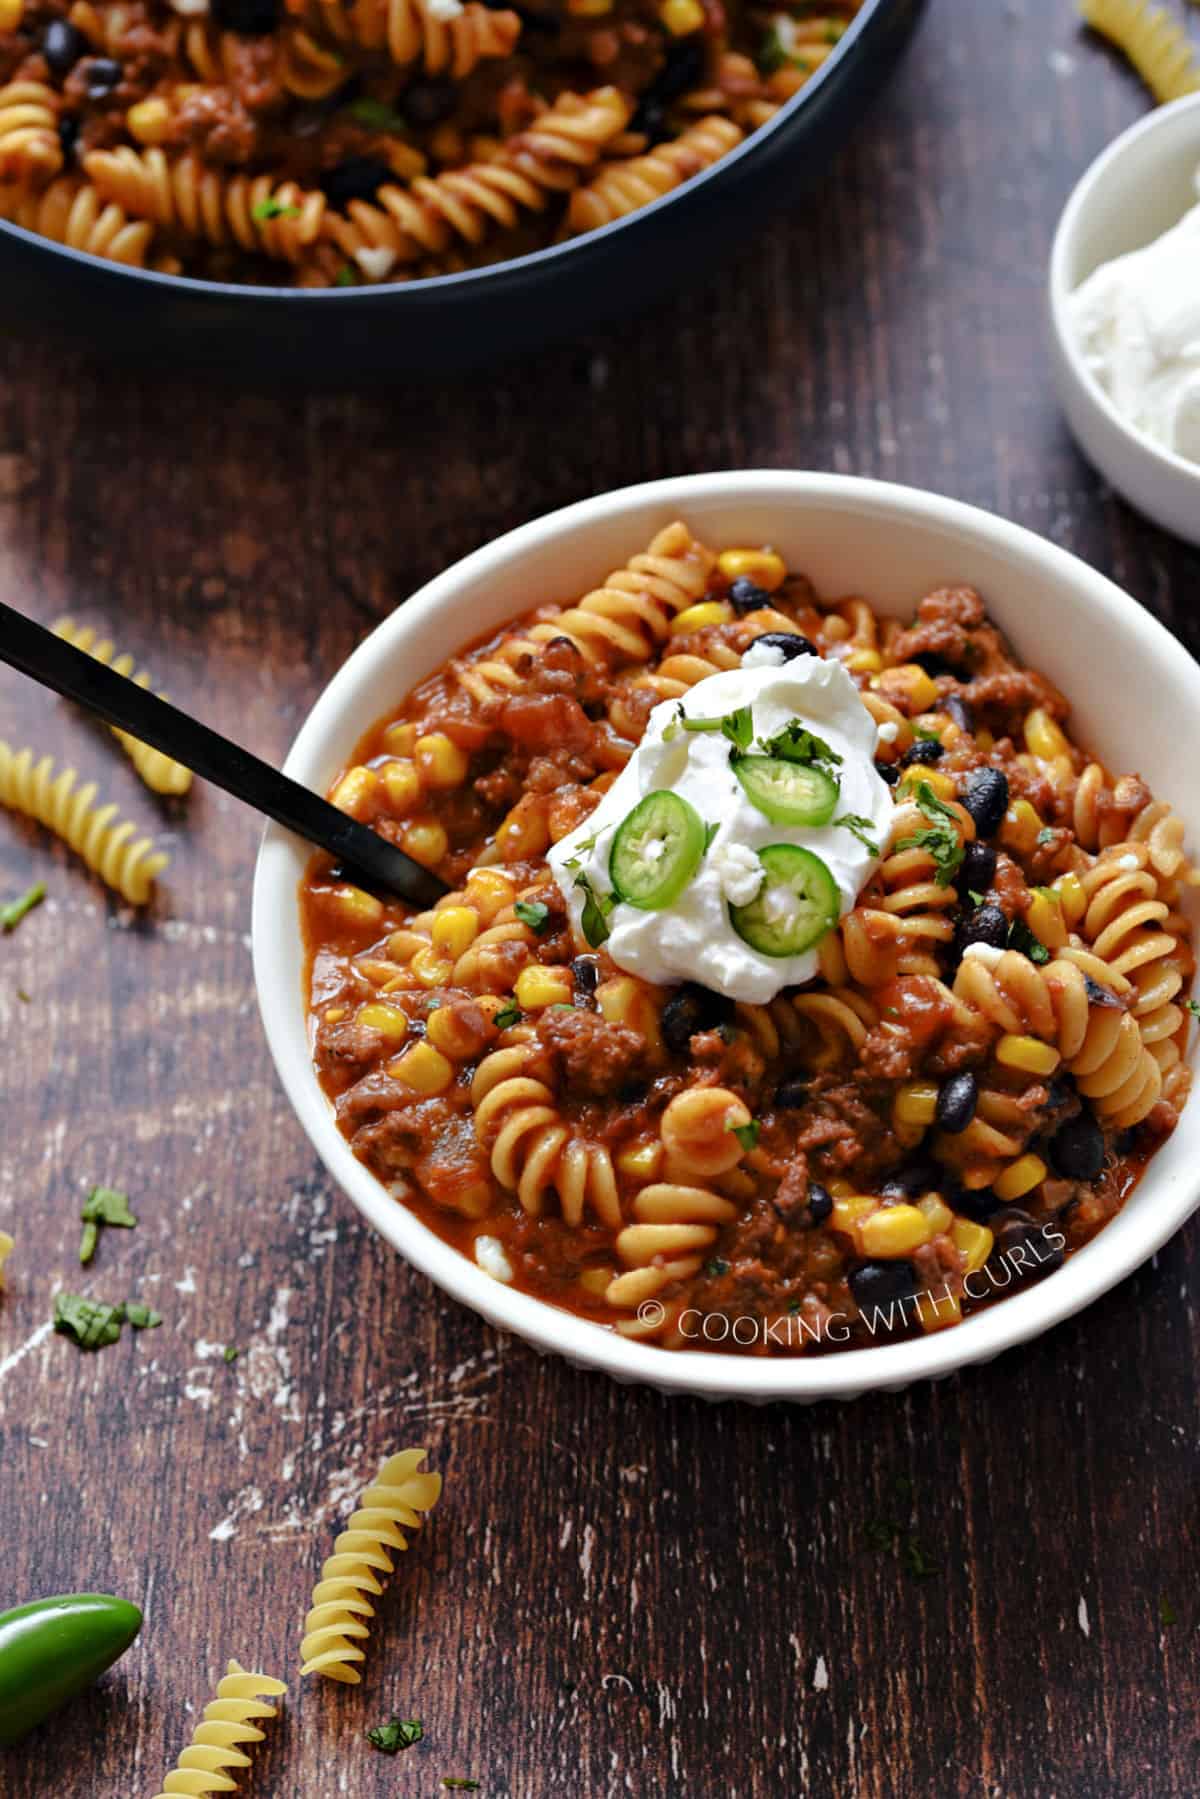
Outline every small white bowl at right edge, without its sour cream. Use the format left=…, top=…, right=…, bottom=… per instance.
left=1049, top=94, right=1200, bottom=543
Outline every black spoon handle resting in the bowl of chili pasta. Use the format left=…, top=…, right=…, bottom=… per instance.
left=0, top=601, right=450, bottom=907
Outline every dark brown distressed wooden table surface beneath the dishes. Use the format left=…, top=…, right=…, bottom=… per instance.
left=0, top=0, right=1200, bottom=1799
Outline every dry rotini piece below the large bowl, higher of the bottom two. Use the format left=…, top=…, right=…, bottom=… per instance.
left=302, top=1450, right=441, bottom=1683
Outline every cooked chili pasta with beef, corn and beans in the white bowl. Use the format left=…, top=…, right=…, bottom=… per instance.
left=302, top=522, right=1200, bottom=1353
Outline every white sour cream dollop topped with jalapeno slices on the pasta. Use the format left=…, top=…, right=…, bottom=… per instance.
left=549, top=657, right=892, bottom=1006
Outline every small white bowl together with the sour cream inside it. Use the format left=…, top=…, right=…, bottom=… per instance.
left=1049, top=94, right=1200, bottom=543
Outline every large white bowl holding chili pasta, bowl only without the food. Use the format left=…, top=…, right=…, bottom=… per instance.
left=254, top=470, right=1200, bottom=1401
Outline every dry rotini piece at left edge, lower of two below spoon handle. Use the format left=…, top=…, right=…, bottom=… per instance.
left=0, top=739, right=171, bottom=905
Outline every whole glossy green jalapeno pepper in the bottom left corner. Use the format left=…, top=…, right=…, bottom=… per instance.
left=0, top=1592, right=142, bottom=1743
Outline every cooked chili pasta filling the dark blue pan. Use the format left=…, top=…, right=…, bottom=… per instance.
left=0, top=0, right=862, bottom=286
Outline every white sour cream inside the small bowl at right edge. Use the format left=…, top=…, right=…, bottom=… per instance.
left=1070, top=175, right=1200, bottom=462
